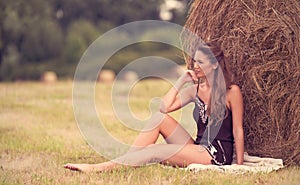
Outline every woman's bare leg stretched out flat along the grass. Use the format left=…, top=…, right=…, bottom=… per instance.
left=65, top=144, right=212, bottom=172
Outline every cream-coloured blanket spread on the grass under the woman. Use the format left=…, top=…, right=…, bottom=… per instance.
left=185, top=152, right=284, bottom=174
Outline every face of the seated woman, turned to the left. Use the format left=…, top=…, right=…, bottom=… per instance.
left=193, top=50, right=218, bottom=78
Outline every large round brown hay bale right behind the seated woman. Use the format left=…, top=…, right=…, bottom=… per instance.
left=183, top=0, right=300, bottom=165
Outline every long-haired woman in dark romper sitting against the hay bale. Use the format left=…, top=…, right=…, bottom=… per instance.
left=64, top=42, right=244, bottom=172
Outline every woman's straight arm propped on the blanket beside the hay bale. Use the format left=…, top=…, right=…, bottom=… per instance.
left=229, top=85, right=244, bottom=164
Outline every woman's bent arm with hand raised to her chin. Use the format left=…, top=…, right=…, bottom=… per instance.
left=160, top=70, right=197, bottom=113
